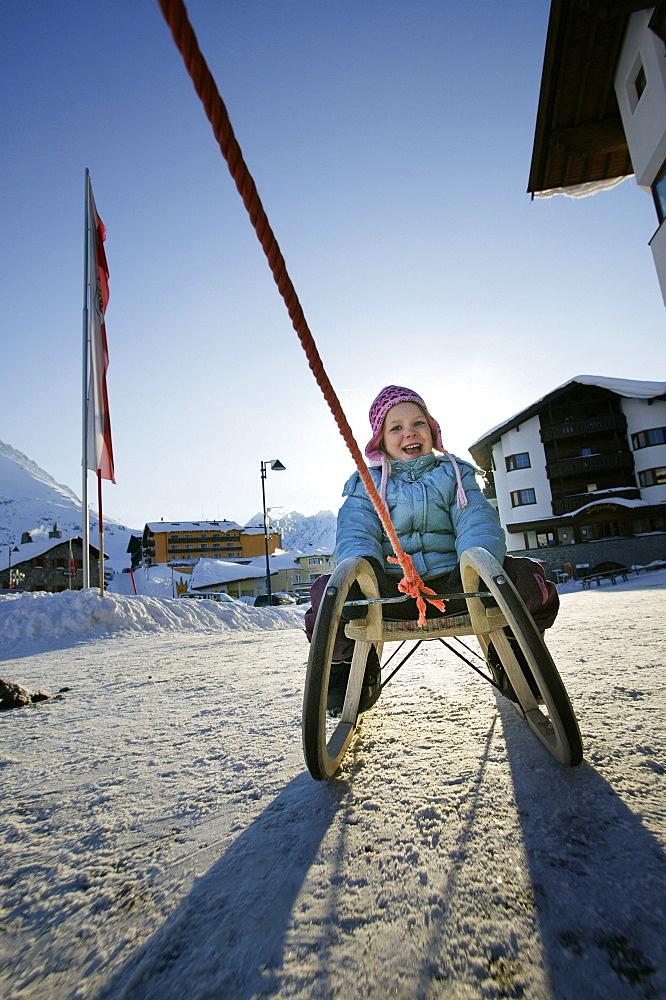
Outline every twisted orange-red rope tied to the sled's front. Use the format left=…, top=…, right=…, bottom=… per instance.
left=159, top=0, right=444, bottom=625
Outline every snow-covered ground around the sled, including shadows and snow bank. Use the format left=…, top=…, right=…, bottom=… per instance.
left=0, top=571, right=666, bottom=1000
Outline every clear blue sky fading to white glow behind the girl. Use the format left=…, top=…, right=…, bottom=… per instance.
left=0, top=0, right=666, bottom=527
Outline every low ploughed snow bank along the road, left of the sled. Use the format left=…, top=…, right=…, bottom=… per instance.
left=0, top=590, right=306, bottom=645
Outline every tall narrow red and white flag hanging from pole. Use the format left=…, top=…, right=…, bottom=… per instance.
left=86, top=181, right=116, bottom=483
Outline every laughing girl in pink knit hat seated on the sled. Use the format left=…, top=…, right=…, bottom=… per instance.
left=305, top=385, right=559, bottom=712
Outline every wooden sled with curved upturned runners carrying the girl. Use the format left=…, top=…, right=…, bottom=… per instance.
left=303, top=548, right=583, bottom=781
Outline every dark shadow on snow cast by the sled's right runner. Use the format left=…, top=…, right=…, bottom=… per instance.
left=490, top=705, right=666, bottom=1000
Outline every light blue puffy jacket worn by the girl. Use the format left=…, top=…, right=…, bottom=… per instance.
left=335, top=454, right=506, bottom=580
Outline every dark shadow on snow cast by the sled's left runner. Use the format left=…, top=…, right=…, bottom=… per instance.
left=96, top=773, right=346, bottom=1000
